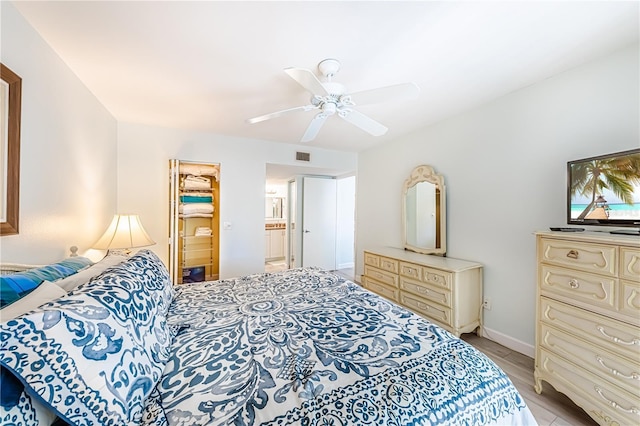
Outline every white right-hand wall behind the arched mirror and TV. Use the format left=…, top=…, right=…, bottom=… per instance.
left=356, top=45, right=640, bottom=355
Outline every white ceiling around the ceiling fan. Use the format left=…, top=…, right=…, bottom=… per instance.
left=10, top=1, right=639, bottom=152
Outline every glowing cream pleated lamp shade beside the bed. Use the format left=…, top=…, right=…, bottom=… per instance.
left=93, top=214, right=155, bottom=250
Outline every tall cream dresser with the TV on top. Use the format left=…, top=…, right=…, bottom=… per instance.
left=535, top=232, right=640, bottom=425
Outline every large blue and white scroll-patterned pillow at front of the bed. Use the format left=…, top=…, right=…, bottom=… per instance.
left=0, top=250, right=174, bottom=425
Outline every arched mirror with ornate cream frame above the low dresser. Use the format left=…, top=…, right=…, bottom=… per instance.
left=402, top=165, right=447, bottom=256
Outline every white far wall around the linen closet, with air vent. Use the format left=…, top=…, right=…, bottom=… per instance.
left=114, top=123, right=357, bottom=278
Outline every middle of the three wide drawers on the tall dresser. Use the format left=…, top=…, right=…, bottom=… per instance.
left=540, top=323, right=640, bottom=393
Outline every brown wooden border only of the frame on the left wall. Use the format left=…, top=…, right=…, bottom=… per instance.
left=0, top=63, right=22, bottom=236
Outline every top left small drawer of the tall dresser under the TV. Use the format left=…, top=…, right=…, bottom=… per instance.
left=539, top=238, right=618, bottom=276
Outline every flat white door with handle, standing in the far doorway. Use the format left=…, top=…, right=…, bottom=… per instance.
left=302, top=177, right=337, bottom=270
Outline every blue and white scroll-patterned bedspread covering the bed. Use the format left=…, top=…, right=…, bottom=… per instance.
left=151, top=268, right=535, bottom=426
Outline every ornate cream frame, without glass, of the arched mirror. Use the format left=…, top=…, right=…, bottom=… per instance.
left=402, top=164, right=447, bottom=256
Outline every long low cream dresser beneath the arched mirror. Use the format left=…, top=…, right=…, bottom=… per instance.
left=362, top=247, right=482, bottom=336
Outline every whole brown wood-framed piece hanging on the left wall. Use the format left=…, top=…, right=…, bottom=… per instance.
left=0, top=63, right=22, bottom=236
